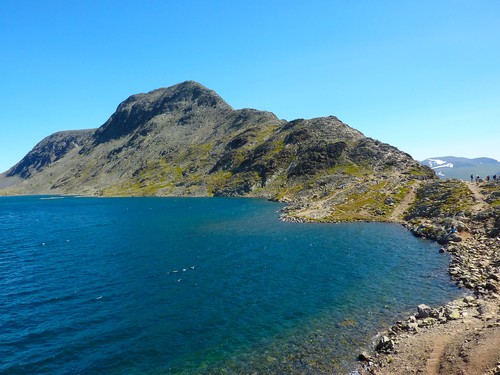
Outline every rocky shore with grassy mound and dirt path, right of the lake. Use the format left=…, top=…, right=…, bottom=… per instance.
left=358, top=180, right=500, bottom=375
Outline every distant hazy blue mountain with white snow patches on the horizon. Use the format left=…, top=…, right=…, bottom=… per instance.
left=422, top=156, right=500, bottom=180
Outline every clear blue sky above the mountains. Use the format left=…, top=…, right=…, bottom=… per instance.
left=0, top=0, right=500, bottom=171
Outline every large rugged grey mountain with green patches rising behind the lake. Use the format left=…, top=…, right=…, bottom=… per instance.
left=0, top=81, right=434, bottom=220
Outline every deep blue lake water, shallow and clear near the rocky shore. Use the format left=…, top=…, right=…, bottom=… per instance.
left=0, top=197, right=460, bottom=374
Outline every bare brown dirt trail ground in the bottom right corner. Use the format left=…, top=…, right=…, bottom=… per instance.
left=360, top=301, right=500, bottom=375
